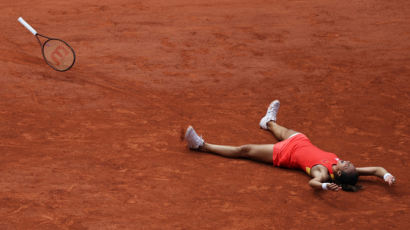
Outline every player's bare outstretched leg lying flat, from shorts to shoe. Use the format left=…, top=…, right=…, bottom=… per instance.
left=199, top=142, right=273, bottom=163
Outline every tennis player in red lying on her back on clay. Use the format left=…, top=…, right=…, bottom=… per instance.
left=185, top=100, right=395, bottom=192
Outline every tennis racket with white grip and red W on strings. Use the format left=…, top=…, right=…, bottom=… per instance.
left=18, top=17, right=75, bottom=72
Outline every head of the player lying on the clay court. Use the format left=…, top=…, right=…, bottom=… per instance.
left=334, top=160, right=360, bottom=192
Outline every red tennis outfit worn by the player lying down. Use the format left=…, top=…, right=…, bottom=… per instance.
left=273, top=133, right=339, bottom=179
